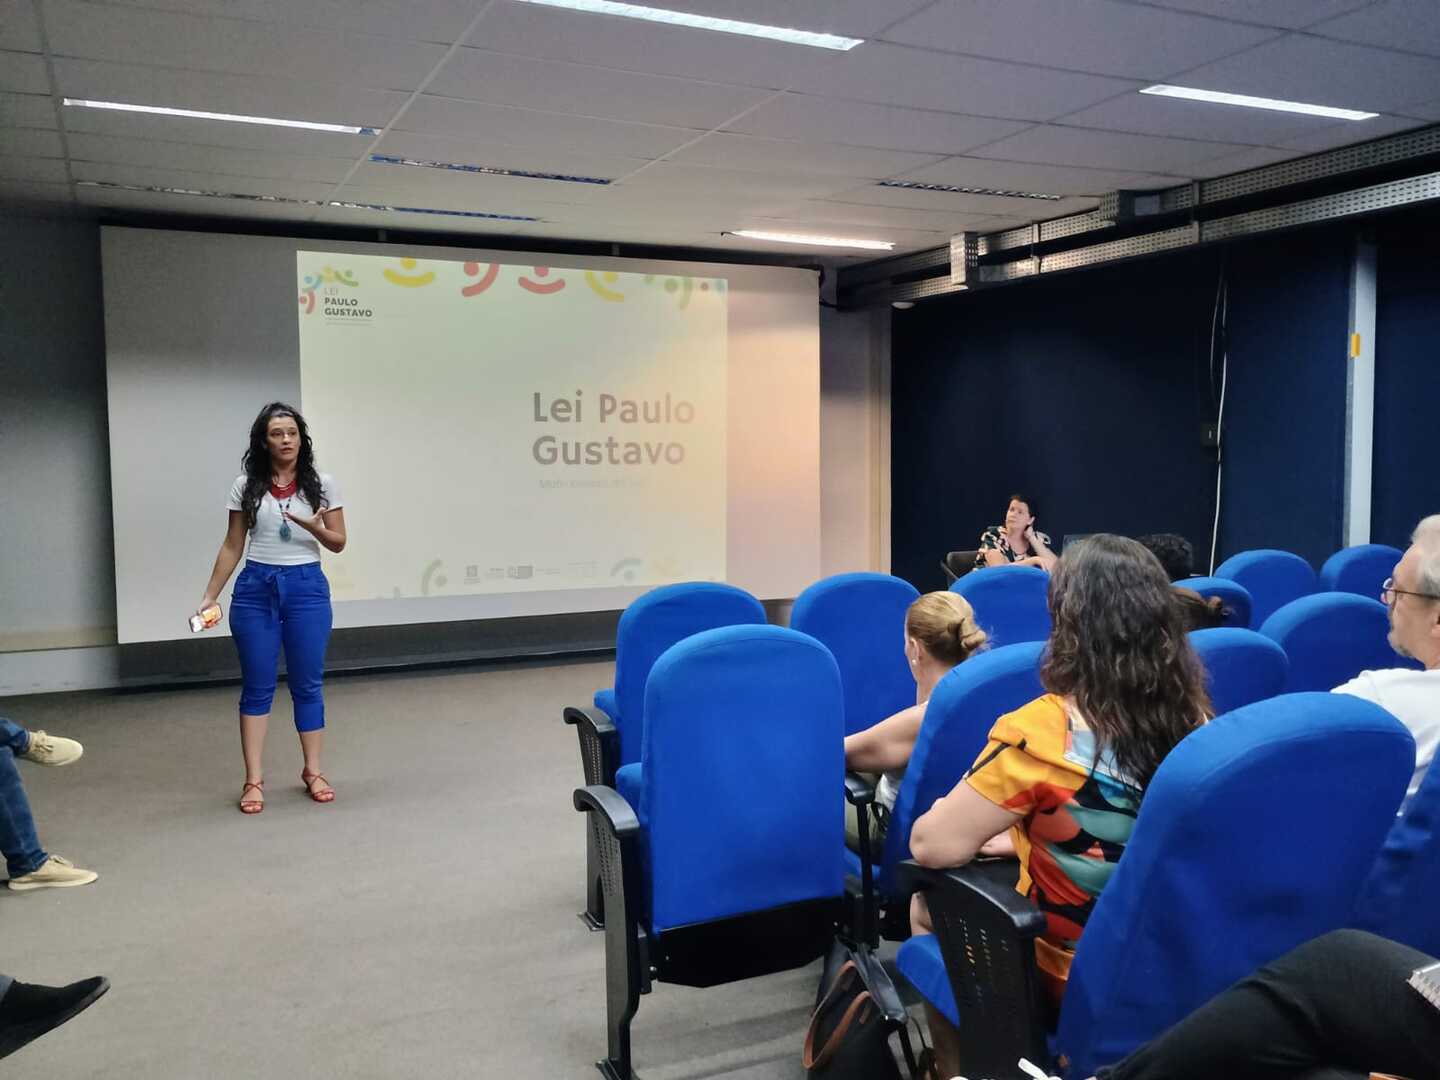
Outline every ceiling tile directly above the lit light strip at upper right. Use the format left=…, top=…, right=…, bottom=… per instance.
left=1181, top=35, right=1440, bottom=112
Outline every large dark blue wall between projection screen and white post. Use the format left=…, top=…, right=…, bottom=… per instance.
left=891, top=230, right=1351, bottom=588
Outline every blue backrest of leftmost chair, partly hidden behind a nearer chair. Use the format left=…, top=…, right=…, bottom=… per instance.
left=612, top=582, right=765, bottom=765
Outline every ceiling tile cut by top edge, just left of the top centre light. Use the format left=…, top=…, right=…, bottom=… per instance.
left=90, top=0, right=478, bottom=43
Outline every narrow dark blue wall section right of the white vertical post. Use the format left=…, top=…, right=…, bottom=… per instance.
left=1371, top=213, right=1440, bottom=547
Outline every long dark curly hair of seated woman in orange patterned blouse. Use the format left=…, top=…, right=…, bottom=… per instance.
left=1040, top=533, right=1212, bottom=791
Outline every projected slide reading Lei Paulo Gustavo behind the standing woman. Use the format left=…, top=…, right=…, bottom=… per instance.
left=295, top=251, right=727, bottom=610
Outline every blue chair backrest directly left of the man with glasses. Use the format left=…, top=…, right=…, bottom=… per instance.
left=1260, top=592, right=1418, bottom=693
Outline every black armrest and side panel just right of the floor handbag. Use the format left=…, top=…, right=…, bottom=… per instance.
left=897, top=861, right=1048, bottom=1076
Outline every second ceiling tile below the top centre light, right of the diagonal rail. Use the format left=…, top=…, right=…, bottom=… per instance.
left=426, top=49, right=772, bottom=128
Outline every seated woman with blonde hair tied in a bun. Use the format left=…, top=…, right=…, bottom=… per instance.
left=845, top=592, right=985, bottom=852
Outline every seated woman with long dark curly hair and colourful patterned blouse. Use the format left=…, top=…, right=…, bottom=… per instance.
left=910, top=534, right=1211, bottom=1076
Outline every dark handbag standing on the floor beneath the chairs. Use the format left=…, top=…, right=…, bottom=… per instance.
left=804, top=937, right=920, bottom=1080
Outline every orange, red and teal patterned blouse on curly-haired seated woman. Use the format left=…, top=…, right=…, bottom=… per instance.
left=965, top=694, right=1140, bottom=999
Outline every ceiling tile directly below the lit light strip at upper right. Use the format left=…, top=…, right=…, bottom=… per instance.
left=1064, top=94, right=1335, bottom=145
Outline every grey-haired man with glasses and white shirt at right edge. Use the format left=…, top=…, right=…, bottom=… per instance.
left=1335, top=514, right=1440, bottom=809
